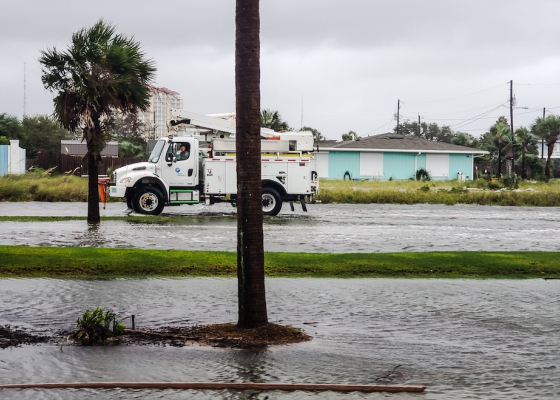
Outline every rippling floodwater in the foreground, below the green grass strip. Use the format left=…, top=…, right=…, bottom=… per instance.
left=0, top=278, right=560, bottom=400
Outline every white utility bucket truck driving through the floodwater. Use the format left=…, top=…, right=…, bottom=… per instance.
left=109, top=110, right=319, bottom=215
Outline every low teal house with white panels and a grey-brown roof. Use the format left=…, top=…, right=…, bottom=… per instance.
left=316, top=133, right=488, bottom=180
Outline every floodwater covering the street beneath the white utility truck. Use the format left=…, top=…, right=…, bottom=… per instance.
left=0, top=202, right=560, bottom=253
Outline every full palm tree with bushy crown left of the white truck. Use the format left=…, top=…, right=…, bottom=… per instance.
left=39, top=20, right=156, bottom=224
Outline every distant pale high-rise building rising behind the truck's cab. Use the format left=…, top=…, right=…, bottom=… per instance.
left=138, top=86, right=183, bottom=139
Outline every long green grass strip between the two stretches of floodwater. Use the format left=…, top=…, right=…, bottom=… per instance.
left=0, top=246, right=560, bottom=279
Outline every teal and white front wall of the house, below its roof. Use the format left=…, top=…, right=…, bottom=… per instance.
left=326, top=151, right=473, bottom=180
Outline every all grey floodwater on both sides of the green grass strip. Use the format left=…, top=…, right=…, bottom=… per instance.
left=0, top=203, right=560, bottom=400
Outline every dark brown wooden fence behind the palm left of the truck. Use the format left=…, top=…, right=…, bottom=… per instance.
left=35, top=150, right=146, bottom=175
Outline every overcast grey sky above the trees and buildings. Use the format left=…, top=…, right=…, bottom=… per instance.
left=0, top=0, right=560, bottom=139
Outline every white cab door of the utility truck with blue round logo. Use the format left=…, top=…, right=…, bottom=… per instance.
left=161, top=138, right=198, bottom=187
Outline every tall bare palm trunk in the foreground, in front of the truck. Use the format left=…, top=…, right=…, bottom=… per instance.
left=235, top=0, right=268, bottom=328
